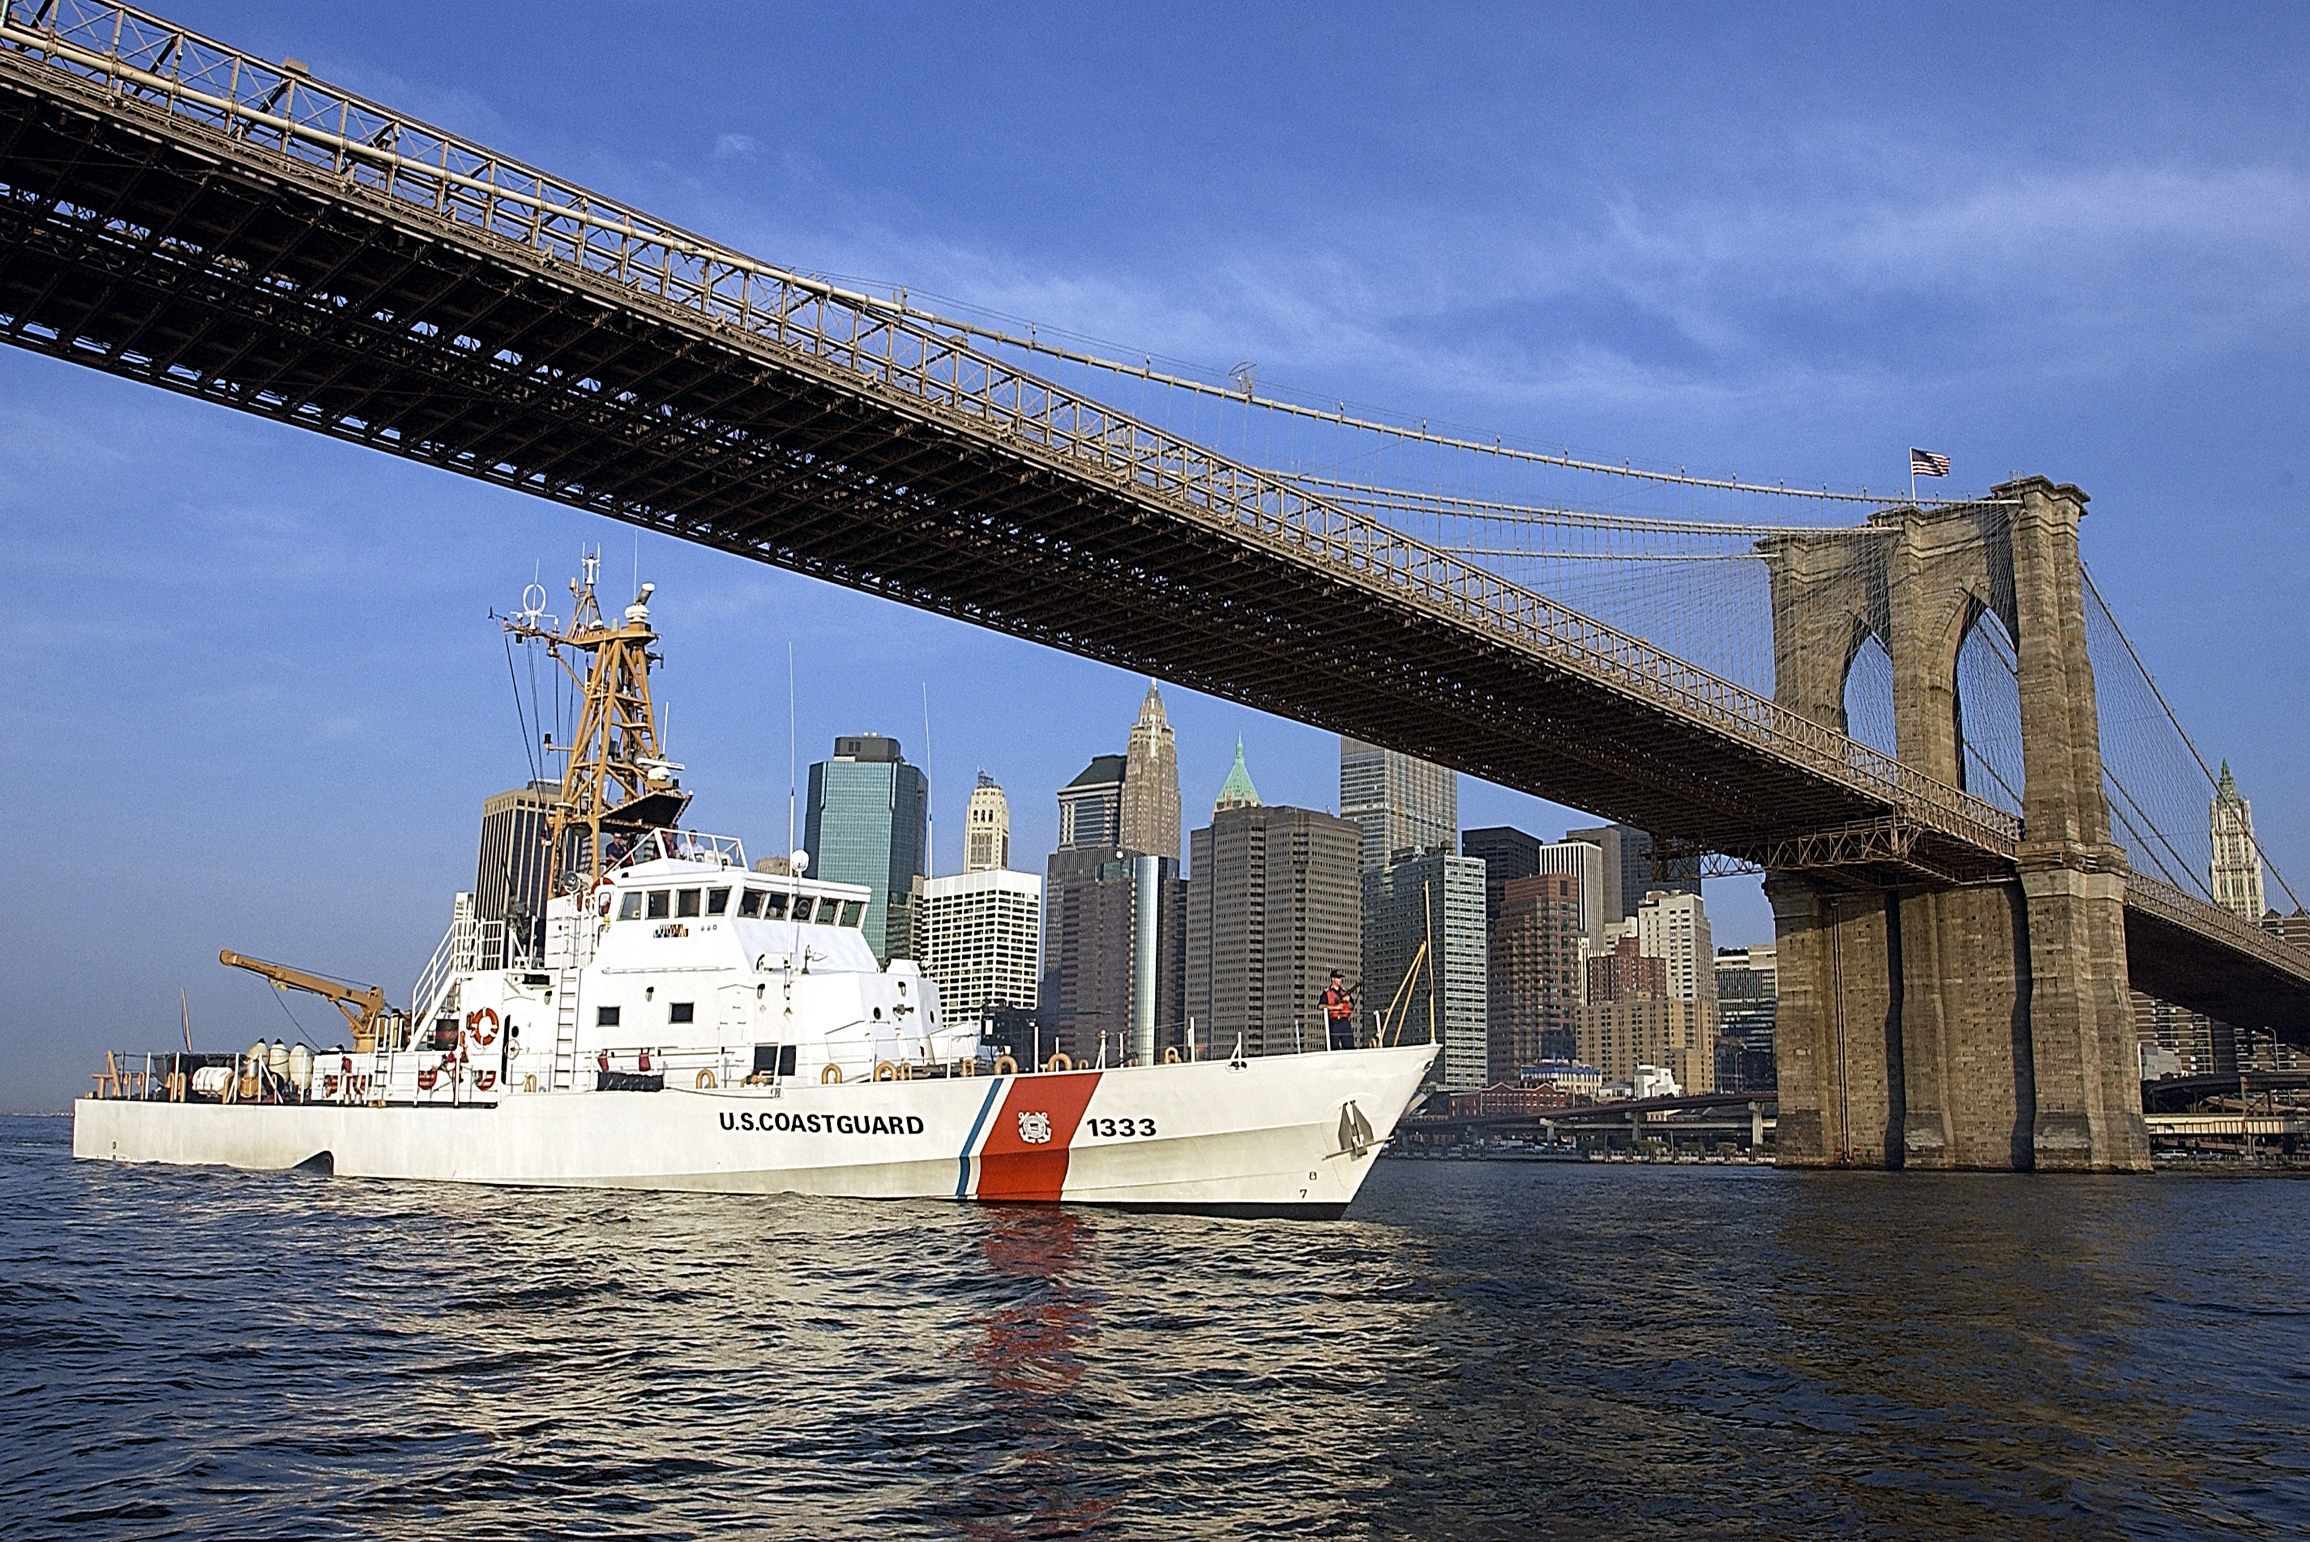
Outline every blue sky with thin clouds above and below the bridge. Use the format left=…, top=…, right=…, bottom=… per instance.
left=0, top=0, right=2310, bottom=1108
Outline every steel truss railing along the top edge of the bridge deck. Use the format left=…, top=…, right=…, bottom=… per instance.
left=0, top=0, right=2021, bottom=861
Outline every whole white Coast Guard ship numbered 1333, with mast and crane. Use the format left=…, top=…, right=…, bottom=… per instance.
left=72, top=559, right=1437, bottom=1219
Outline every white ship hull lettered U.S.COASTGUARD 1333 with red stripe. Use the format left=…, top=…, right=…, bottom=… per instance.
left=72, top=1043, right=1437, bottom=1217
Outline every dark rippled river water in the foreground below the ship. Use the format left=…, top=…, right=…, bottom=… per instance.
left=0, top=1120, right=2310, bottom=1542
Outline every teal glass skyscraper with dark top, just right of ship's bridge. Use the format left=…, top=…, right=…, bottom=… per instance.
left=802, top=734, right=931, bottom=963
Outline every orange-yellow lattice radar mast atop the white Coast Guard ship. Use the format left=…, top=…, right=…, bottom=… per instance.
left=504, top=549, right=691, bottom=893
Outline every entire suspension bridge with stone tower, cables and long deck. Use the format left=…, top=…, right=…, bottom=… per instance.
left=0, top=0, right=2310, bottom=1170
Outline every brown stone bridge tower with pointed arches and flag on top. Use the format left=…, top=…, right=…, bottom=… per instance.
left=1765, top=478, right=2148, bottom=1173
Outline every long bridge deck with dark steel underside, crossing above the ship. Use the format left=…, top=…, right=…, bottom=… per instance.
left=0, top=0, right=2310, bottom=1034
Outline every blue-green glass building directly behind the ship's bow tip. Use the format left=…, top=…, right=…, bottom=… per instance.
left=1358, top=852, right=1487, bottom=1087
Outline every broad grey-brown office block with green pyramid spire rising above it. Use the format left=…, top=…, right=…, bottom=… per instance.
left=1185, top=746, right=1358, bottom=1055
